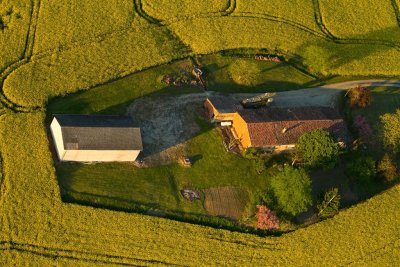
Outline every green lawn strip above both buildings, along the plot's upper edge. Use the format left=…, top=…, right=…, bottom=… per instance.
left=47, top=55, right=322, bottom=115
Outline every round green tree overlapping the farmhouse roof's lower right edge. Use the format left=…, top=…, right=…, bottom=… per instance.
left=296, top=129, right=340, bottom=169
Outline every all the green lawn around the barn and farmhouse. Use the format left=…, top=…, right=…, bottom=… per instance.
left=48, top=55, right=400, bottom=230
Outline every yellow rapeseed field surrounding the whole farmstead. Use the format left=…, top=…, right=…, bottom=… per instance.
left=0, top=0, right=400, bottom=266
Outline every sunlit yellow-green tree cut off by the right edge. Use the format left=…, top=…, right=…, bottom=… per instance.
left=380, top=109, right=400, bottom=153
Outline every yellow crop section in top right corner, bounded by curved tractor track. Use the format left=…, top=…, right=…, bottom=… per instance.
left=319, top=0, right=400, bottom=42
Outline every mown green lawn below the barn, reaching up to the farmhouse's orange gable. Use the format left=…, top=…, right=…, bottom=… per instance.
left=57, top=121, right=269, bottom=219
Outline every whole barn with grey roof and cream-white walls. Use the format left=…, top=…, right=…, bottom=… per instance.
left=50, top=115, right=143, bottom=162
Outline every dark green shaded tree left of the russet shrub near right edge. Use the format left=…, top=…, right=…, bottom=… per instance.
left=346, top=156, right=376, bottom=184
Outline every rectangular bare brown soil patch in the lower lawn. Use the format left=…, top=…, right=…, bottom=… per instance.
left=204, top=186, right=248, bottom=220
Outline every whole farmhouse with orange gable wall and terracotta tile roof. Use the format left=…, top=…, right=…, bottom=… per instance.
left=204, top=95, right=350, bottom=152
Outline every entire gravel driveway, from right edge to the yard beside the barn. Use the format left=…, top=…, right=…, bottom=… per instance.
left=127, top=80, right=400, bottom=166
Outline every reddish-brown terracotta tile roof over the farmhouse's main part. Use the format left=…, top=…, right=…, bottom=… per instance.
left=239, top=107, right=350, bottom=147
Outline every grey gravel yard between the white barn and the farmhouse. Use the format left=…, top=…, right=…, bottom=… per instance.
left=127, top=93, right=205, bottom=166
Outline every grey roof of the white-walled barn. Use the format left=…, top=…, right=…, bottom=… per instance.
left=54, top=115, right=143, bottom=150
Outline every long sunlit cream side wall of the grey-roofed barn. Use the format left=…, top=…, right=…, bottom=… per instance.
left=61, top=150, right=140, bottom=162
